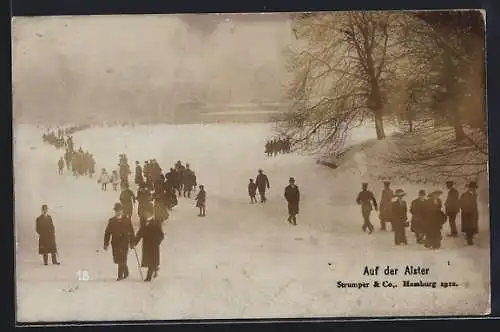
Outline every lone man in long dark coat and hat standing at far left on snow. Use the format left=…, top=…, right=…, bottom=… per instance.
left=36, top=204, right=60, bottom=265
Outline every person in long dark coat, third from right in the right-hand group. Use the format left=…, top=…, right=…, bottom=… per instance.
left=425, top=190, right=446, bottom=249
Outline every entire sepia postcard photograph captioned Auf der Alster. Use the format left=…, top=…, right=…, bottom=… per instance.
left=12, top=10, right=490, bottom=323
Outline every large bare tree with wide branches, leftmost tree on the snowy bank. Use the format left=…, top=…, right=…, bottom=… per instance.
left=281, top=12, right=422, bottom=155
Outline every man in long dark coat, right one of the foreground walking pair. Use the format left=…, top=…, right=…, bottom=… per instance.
left=135, top=209, right=165, bottom=281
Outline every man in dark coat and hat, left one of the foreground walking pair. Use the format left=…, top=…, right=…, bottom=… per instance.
left=103, top=203, right=135, bottom=281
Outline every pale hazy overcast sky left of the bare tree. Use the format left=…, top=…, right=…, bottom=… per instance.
left=12, top=14, right=292, bottom=123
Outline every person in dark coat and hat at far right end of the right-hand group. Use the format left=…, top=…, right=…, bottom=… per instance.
left=460, top=182, right=479, bottom=246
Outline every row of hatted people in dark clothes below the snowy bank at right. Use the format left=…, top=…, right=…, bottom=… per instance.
left=356, top=181, right=479, bottom=249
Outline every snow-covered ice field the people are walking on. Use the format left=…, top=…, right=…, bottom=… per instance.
left=14, top=124, right=490, bottom=322
